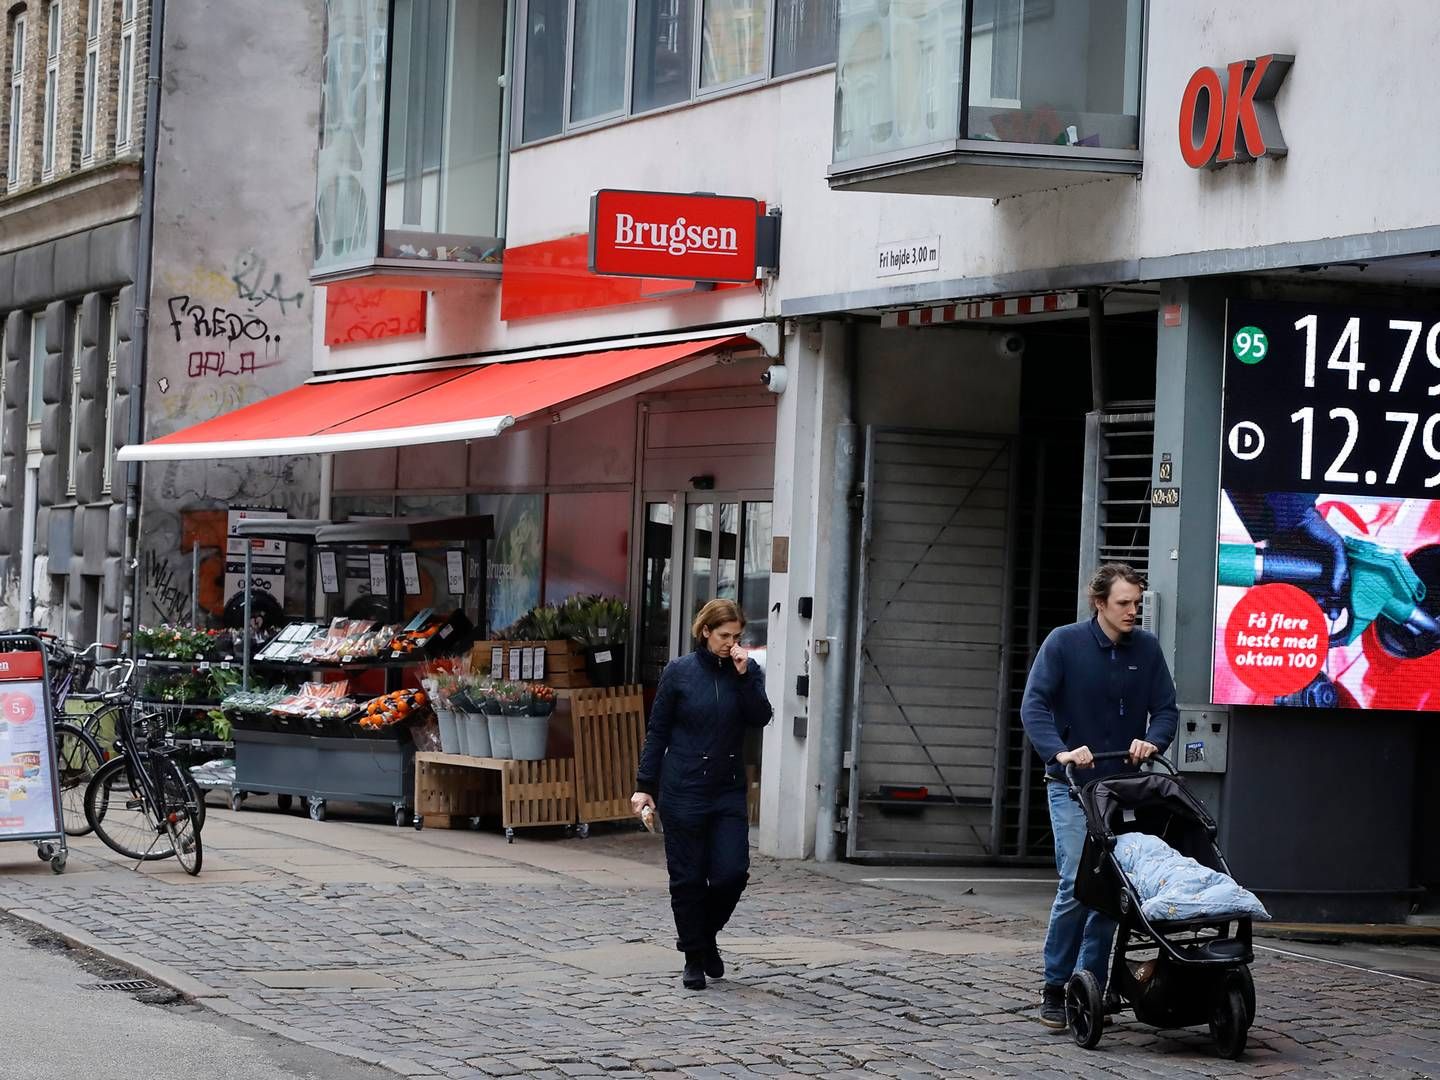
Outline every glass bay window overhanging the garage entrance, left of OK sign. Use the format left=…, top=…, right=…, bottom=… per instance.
left=831, top=0, right=1143, bottom=194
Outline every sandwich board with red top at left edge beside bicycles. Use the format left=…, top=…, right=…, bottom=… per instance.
left=0, top=634, right=69, bottom=874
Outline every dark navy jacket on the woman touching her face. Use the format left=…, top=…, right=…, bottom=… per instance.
left=635, top=645, right=773, bottom=796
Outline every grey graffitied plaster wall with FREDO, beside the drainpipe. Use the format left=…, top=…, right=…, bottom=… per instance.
left=140, top=0, right=324, bottom=622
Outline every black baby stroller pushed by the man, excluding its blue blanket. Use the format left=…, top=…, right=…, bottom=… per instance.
left=1066, top=750, right=1256, bottom=1058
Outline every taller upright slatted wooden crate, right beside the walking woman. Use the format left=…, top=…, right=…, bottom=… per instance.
left=570, top=685, right=645, bottom=822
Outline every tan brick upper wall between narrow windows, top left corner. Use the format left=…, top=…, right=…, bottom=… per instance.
left=0, top=0, right=150, bottom=192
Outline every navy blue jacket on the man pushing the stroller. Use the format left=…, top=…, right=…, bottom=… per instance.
left=1020, top=618, right=1179, bottom=783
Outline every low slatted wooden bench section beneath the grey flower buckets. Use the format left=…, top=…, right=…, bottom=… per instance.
left=415, top=753, right=575, bottom=840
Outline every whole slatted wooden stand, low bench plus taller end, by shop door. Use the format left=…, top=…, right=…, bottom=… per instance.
left=415, top=685, right=645, bottom=841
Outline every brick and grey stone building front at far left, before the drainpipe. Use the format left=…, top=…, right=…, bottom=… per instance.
left=0, top=0, right=150, bottom=641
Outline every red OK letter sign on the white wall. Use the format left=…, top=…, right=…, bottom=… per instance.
left=1179, top=53, right=1295, bottom=168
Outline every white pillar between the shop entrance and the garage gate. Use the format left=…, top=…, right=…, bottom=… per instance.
left=760, top=323, right=844, bottom=858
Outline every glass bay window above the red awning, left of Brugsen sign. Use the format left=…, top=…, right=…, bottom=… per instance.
left=315, top=0, right=505, bottom=281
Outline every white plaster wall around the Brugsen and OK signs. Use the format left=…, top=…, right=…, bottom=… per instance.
left=309, top=0, right=1440, bottom=377
